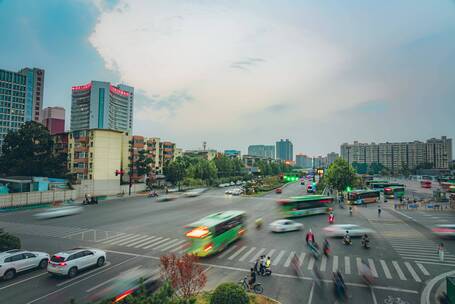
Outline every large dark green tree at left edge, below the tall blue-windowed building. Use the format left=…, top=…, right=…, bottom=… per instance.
left=0, top=121, right=68, bottom=177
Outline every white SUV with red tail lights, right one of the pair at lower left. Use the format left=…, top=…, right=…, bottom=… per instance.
left=47, top=248, right=106, bottom=278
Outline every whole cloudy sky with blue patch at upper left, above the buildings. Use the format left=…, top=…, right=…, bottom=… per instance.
left=0, top=0, right=455, bottom=155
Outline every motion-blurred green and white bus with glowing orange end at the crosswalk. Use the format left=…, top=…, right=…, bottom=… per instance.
left=185, top=210, right=246, bottom=257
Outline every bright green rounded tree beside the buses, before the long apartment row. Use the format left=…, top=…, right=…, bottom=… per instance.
left=324, top=158, right=357, bottom=191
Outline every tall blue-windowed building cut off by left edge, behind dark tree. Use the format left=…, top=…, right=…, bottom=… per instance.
left=0, top=68, right=44, bottom=149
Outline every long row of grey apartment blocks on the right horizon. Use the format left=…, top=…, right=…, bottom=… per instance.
left=340, top=136, right=452, bottom=172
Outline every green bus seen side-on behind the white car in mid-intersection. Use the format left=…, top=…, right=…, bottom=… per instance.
left=277, top=195, right=333, bottom=218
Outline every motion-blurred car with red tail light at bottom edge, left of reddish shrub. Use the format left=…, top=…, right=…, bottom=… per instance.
left=90, top=266, right=162, bottom=303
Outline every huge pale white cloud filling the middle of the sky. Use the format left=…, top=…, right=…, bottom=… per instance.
left=89, top=0, right=450, bottom=152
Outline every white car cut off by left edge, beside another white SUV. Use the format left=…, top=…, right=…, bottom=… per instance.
left=0, top=249, right=49, bottom=281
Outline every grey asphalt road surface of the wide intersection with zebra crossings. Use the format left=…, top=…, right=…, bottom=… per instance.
left=0, top=184, right=455, bottom=304
